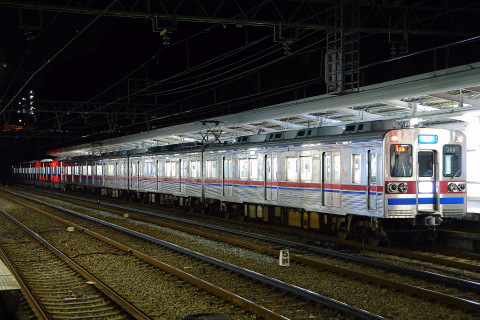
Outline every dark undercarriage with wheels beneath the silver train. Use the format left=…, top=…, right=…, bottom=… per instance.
left=62, top=185, right=440, bottom=245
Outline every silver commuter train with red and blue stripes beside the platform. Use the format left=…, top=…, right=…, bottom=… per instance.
left=13, top=121, right=467, bottom=241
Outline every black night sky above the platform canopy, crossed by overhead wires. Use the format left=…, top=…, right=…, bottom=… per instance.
left=0, top=1, right=480, bottom=179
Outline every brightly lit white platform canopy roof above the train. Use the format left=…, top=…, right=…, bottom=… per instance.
left=47, top=62, right=480, bottom=159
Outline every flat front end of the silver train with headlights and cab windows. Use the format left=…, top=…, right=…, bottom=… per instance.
left=384, top=128, right=467, bottom=226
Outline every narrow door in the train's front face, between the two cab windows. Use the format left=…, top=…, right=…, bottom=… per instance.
left=417, top=150, right=438, bottom=212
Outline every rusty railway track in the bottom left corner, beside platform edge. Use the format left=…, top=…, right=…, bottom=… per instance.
left=0, top=209, right=144, bottom=320
